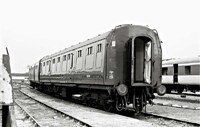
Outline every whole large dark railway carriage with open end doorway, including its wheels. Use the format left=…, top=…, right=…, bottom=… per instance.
left=29, top=25, right=164, bottom=112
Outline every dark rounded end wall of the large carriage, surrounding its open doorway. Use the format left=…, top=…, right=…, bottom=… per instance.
left=106, top=25, right=162, bottom=86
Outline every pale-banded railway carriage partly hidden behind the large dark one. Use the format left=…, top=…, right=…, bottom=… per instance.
left=162, top=57, right=200, bottom=93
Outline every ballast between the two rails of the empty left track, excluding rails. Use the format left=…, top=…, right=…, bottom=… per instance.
left=15, top=92, right=83, bottom=127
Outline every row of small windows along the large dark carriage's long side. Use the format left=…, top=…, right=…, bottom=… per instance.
left=43, top=44, right=102, bottom=68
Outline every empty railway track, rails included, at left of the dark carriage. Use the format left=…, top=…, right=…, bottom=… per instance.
left=15, top=91, right=90, bottom=127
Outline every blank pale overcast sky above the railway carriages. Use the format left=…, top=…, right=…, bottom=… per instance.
left=0, top=0, right=200, bottom=72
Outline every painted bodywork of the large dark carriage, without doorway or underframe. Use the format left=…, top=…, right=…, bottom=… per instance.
left=30, top=25, right=162, bottom=87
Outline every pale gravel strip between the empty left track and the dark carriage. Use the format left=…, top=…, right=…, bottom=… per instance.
left=19, top=89, right=155, bottom=127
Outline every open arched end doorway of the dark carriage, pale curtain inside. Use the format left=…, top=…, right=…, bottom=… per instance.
left=131, top=36, right=152, bottom=86
